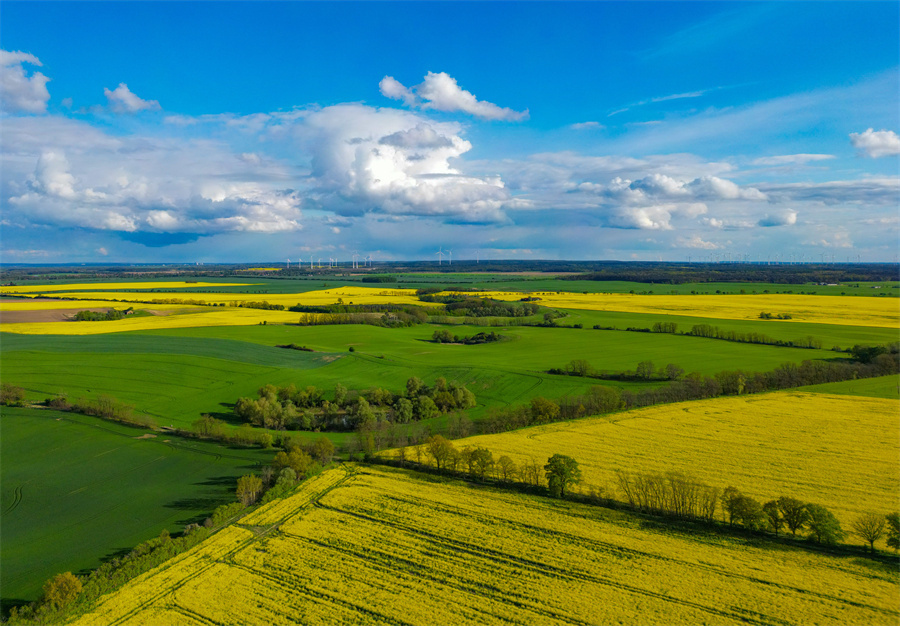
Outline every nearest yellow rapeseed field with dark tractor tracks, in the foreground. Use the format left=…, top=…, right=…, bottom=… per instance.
left=74, top=467, right=900, bottom=626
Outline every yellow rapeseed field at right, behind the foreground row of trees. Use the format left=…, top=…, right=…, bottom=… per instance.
left=446, top=391, right=900, bottom=528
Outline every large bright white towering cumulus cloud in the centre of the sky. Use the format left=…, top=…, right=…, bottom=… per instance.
left=303, top=104, right=510, bottom=222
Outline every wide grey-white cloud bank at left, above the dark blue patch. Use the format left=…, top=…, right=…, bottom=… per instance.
left=3, top=118, right=302, bottom=240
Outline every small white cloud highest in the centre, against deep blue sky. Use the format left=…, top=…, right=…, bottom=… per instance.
left=378, top=72, right=528, bottom=122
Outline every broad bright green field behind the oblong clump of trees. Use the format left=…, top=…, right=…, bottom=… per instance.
left=2, top=322, right=852, bottom=426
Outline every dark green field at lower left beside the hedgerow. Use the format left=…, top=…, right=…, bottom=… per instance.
left=0, top=407, right=273, bottom=605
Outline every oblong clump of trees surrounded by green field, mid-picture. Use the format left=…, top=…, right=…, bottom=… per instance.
left=234, top=376, right=476, bottom=431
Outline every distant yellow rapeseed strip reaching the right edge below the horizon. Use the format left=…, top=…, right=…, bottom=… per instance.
left=468, top=291, right=900, bottom=328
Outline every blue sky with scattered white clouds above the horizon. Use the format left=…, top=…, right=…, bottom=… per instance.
left=0, top=0, right=900, bottom=263
